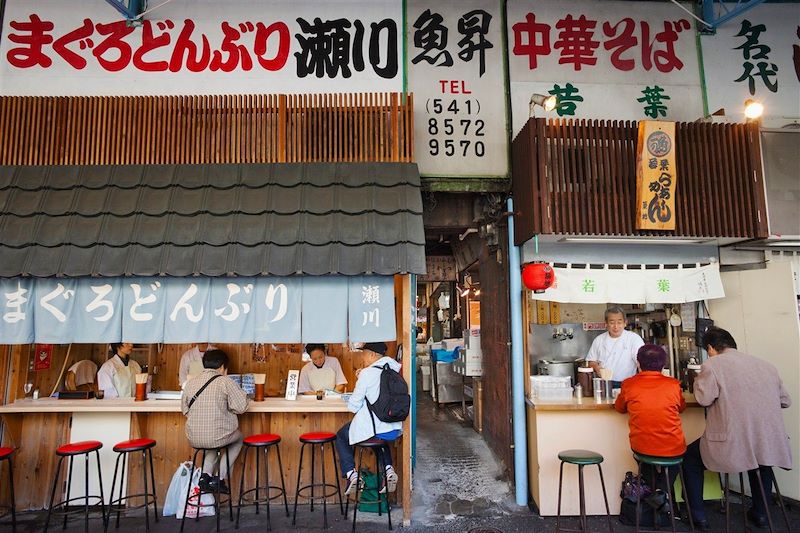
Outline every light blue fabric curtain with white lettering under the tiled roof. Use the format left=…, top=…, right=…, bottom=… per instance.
left=0, top=276, right=396, bottom=344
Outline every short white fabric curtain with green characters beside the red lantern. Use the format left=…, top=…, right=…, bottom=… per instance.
left=530, top=263, right=725, bottom=304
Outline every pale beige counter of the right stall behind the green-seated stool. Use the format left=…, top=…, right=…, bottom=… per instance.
left=526, top=394, right=705, bottom=516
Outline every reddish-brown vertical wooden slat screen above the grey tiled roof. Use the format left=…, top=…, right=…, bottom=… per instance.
left=0, top=93, right=414, bottom=165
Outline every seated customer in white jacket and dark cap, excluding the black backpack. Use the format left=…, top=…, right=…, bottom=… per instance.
left=336, top=342, right=403, bottom=495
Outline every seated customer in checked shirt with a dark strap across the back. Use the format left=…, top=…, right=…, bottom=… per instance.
left=181, top=350, right=248, bottom=494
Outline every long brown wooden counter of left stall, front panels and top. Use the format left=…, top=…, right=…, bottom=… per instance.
left=0, top=396, right=400, bottom=509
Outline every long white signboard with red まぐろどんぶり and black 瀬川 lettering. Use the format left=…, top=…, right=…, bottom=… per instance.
left=0, top=0, right=403, bottom=96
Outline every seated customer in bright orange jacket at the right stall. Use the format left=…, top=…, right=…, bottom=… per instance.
left=614, top=344, right=686, bottom=487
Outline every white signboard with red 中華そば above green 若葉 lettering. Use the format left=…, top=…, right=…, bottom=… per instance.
left=508, top=0, right=703, bottom=135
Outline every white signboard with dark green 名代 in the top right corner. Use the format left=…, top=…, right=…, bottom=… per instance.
left=700, top=4, right=800, bottom=127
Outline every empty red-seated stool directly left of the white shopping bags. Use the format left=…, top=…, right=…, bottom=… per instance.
left=106, top=439, right=158, bottom=531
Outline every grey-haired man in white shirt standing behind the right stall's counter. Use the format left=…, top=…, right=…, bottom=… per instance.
left=586, top=306, right=644, bottom=388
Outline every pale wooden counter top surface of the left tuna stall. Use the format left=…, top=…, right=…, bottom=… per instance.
left=0, top=396, right=354, bottom=414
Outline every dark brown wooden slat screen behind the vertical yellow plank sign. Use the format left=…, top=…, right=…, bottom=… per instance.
left=512, top=119, right=768, bottom=245
